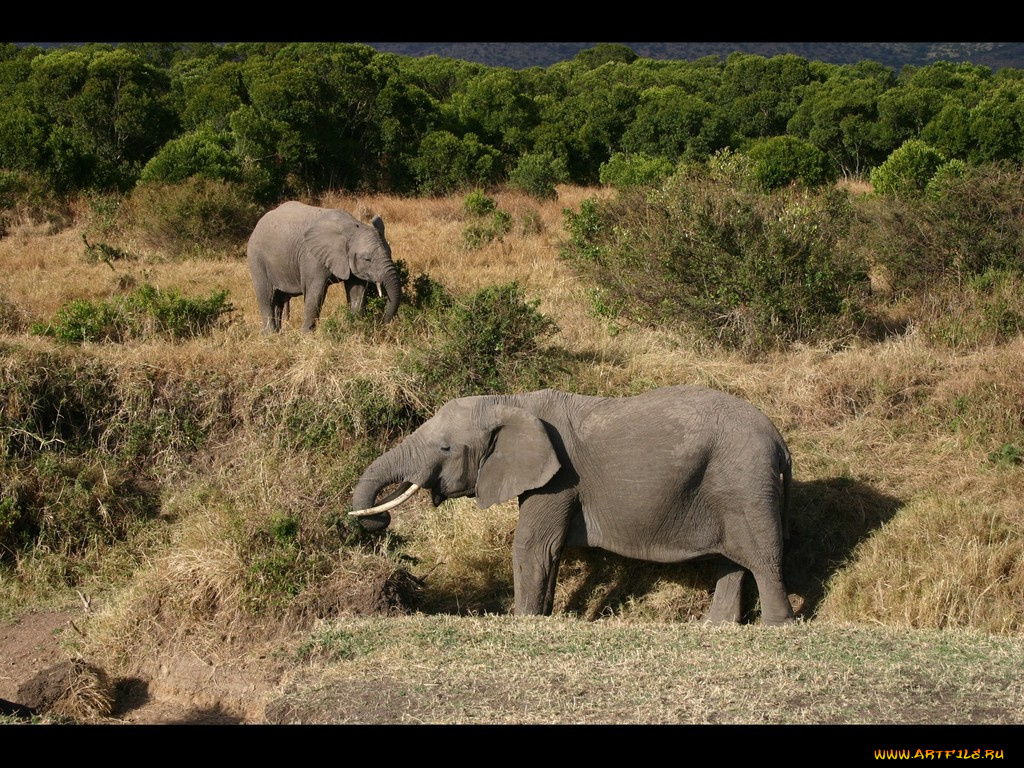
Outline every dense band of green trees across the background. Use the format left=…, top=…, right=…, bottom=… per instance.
left=0, top=43, right=1024, bottom=202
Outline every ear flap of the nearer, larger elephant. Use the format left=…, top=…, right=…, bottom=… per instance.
left=476, top=406, right=561, bottom=509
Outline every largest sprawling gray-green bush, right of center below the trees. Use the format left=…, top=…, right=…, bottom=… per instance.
left=562, top=169, right=866, bottom=352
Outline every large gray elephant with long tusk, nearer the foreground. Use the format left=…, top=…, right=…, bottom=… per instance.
left=350, top=386, right=794, bottom=625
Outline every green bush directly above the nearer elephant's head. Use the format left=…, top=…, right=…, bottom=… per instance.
left=407, top=283, right=558, bottom=413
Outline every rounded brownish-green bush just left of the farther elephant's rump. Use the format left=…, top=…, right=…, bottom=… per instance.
left=129, top=176, right=263, bottom=257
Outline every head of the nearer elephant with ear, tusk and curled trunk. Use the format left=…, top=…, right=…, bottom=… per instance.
left=351, top=396, right=560, bottom=530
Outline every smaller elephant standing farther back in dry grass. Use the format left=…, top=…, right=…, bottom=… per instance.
left=246, top=201, right=401, bottom=332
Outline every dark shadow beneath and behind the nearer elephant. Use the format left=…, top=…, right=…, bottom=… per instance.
left=556, top=477, right=903, bottom=622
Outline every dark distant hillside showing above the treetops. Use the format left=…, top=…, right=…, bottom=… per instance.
left=369, top=42, right=1024, bottom=72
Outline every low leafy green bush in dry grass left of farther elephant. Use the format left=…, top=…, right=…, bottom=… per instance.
left=31, top=284, right=232, bottom=344
